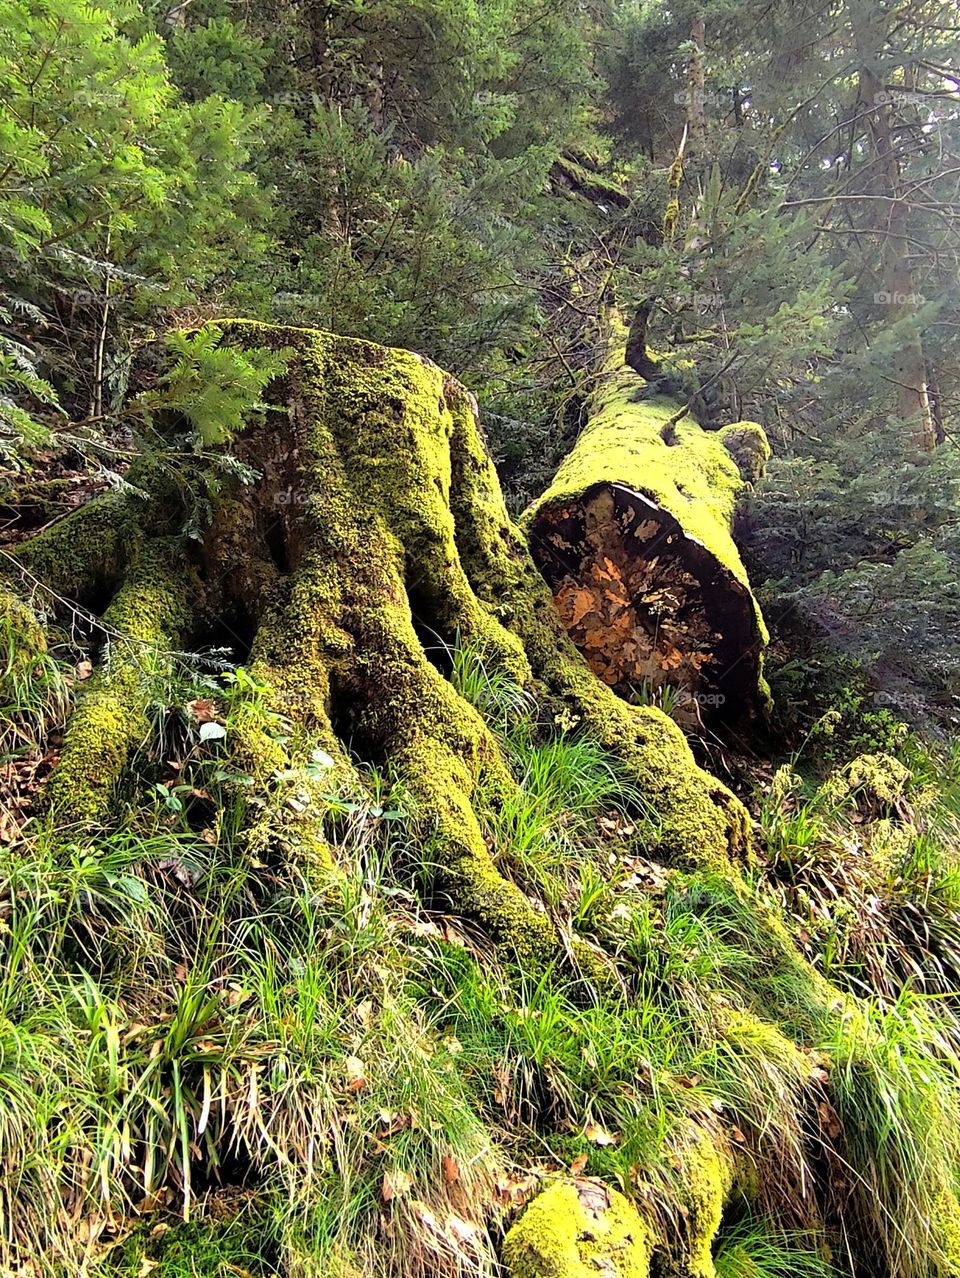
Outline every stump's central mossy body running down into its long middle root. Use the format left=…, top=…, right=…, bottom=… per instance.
left=213, top=323, right=559, bottom=961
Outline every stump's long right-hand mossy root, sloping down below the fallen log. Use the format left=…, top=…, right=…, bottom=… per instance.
left=451, top=389, right=749, bottom=868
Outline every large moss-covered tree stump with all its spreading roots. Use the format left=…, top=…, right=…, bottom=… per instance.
left=5, top=322, right=757, bottom=962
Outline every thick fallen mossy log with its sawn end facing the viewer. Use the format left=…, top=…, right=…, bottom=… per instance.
left=523, top=357, right=768, bottom=728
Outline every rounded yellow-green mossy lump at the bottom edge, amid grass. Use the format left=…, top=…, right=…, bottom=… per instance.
left=502, top=1180, right=653, bottom=1278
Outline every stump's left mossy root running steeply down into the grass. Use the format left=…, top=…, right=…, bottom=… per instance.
left=43, top=539, right=190, bottom=822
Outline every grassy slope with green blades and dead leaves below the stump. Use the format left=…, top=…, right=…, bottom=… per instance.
left=0, top=633, right=960, bottom=1278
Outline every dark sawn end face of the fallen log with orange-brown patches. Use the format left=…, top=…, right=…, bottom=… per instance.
left=530, top=483, right=761, bottom=730
